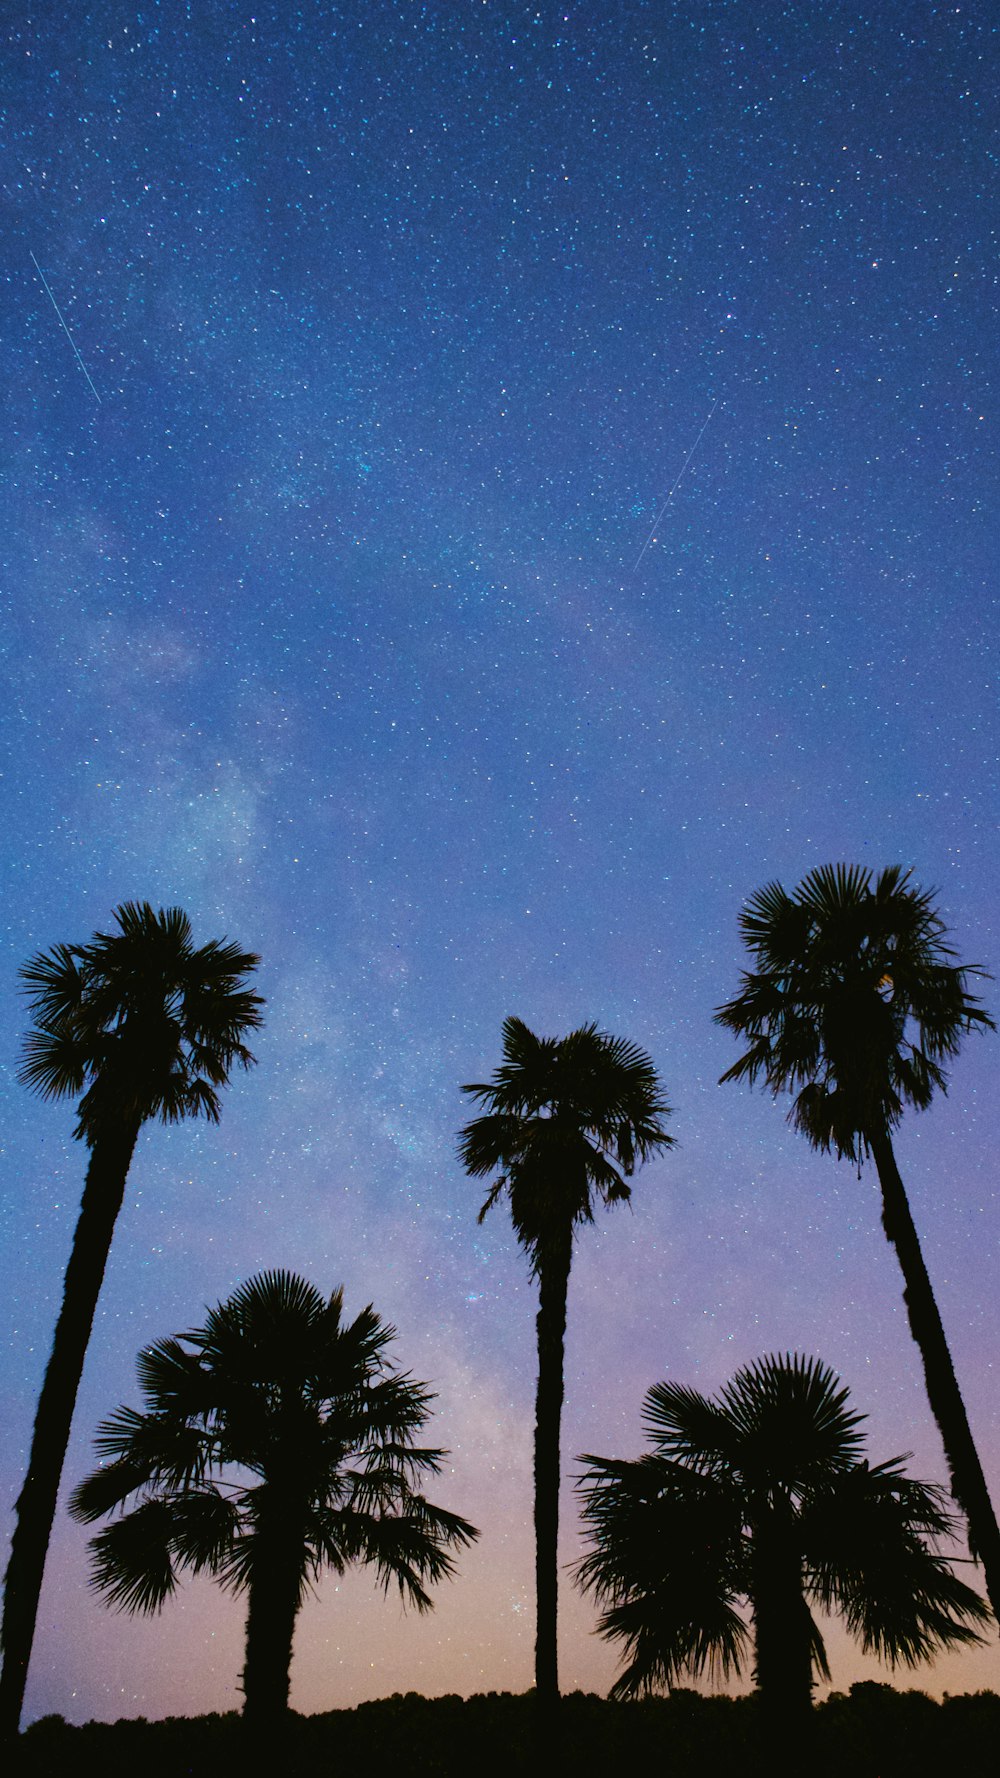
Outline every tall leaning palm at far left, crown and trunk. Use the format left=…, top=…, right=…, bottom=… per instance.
left=0, top=901, right=262, bottom=1744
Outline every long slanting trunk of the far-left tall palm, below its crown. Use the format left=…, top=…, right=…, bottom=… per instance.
left=0, top=1118, right=141, bottom=1746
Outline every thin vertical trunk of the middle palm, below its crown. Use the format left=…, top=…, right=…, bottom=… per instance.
left=536, top=1229, right=573, bottom=1705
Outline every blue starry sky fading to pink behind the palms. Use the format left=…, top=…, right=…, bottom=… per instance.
left=0, top=0, right=1000, bottom=1721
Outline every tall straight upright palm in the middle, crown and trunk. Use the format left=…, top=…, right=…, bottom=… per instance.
left=459, top=1019, right=673, bottom=1703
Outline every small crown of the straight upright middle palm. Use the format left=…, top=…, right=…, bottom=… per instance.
left=459, top=1019, right=674, bottom=1273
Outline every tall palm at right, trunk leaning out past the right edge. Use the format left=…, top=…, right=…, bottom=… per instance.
left=715, top=864, right=1000, bottom=1618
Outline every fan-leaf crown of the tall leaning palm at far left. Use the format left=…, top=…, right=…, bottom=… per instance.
left=20, top=901, right=263, bottom=1147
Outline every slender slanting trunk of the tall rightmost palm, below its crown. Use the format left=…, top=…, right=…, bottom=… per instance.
left=868, top=1129, right=1000, bottom=1622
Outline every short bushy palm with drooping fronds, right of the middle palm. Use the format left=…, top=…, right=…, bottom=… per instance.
left=577, top=1357, right=989, bottom=1737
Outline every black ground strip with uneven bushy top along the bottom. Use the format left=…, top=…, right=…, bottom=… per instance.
left=21, top=1680, right=1000, bottom=1778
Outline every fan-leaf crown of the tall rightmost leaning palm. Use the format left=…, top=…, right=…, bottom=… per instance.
left=715, top=864, right=993, bottom=1159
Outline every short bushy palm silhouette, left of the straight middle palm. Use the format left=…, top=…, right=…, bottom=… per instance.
left=69, top=1271, right=479, bottom=1730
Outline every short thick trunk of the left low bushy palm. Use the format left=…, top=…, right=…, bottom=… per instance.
left=242, top=1515, right=302, bottom=1735
